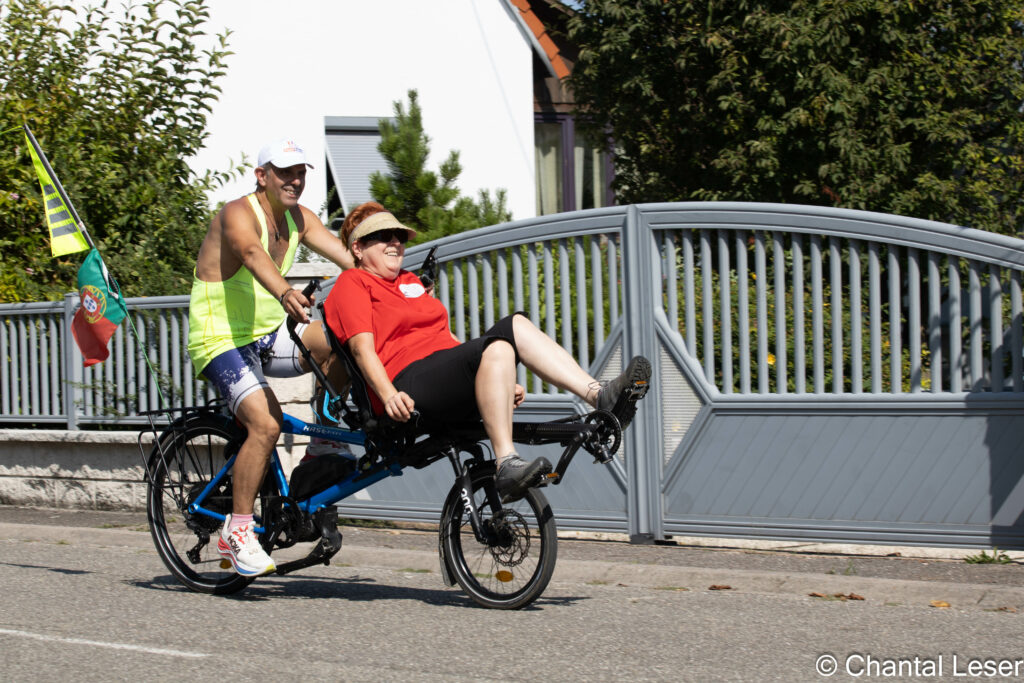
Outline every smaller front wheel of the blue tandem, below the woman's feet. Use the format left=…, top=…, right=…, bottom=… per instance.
left=441, top=463, right=558, bottom=609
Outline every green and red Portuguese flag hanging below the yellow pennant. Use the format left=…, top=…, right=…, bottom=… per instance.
left=71, top=249, right=128, bottom=368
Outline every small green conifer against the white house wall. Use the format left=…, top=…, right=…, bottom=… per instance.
left=370, top=90, right=512, bottom=242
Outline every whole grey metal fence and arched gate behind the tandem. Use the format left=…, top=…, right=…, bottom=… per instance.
left=6, top=203, right=1024, bottom=547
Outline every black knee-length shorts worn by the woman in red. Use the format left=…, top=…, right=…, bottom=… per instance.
left=393, top=313, right=522, bottom=422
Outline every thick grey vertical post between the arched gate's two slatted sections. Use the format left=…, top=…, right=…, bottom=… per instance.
left=623, top=206, right=665, bottom=543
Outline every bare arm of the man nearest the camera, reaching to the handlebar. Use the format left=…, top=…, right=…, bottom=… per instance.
left=220, top=203, right=309, bottom=323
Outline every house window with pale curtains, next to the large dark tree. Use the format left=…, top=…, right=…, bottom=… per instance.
left=534, top=114, right=614, bottom=216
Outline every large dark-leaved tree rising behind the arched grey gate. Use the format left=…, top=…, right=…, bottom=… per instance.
left=569, top=0, right=1024, bottom=234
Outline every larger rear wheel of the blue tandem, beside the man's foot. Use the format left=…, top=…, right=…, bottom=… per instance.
left=146, top=414, right=269, bottom=595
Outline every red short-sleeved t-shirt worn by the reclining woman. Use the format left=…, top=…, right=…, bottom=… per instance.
left=324, top=268, right=459, bottom=413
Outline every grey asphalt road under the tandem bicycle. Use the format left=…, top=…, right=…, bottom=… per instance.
left=0, top=508, right=1024, bottom=681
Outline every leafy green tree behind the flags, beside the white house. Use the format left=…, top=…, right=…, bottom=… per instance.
left=0, top=0, right=229, bottom=301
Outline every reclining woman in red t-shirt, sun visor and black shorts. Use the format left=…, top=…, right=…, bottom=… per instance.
left=325, top=202, right=650, bottom=500
